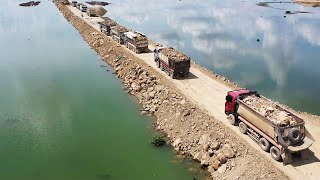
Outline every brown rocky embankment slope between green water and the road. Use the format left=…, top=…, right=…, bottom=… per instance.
left=56, top=4, right=288, bottom=179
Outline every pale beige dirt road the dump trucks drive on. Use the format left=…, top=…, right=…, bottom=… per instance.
left=69, top=6, right=320, bottom=179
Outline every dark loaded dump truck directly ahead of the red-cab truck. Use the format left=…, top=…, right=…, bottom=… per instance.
left=154, top=47, right=191, bottom=79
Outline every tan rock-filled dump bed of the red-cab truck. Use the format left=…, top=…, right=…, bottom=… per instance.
left=237, top=94, right=314, bottom=152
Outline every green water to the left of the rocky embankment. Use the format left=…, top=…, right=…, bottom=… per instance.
left=0, top=0, right=203, bottom=180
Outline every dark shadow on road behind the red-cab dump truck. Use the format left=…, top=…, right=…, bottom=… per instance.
left=292, top=149, right=320, bottom=167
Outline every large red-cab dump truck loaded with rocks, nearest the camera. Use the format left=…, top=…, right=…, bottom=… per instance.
left=225, top=89, right=314, bottom=164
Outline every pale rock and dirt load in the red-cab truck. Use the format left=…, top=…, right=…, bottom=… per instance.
left=243, top=95, right=297, bottom=127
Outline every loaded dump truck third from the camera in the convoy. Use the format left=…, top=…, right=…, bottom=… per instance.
left=125, top=31, right=148, bottom=54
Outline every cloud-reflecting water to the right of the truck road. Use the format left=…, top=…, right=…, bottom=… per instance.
left=106, top=0, right=320, bottom=115
